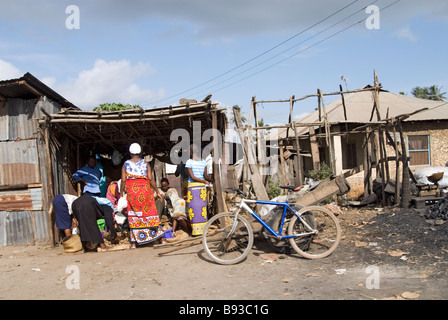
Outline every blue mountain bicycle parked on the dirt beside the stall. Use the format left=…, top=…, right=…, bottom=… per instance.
left=202, top=186, right=341, bottom=264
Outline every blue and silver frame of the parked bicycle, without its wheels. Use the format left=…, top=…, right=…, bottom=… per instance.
left=234, top=199, right=317, bottom=239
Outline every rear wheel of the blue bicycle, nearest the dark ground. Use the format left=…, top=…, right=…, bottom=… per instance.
left=288, top=206, right=341, bottom=259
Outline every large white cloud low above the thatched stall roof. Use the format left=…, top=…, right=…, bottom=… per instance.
left=55, top=59, right=164, bottom=110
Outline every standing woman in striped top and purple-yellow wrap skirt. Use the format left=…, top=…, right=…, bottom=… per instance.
left=185, top=144, right=210, bottom=236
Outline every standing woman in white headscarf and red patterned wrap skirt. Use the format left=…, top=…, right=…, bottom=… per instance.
left=120, top=143, right=164, bottom=249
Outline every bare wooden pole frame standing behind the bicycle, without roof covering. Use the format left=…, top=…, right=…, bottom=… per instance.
left=234, top=71, right=427, bottom=207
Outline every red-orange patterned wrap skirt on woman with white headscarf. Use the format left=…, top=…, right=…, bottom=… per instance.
left=126, top=179, right=163, bottom=245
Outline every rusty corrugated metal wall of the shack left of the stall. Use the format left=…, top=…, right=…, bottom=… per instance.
left=0, top=99, right=63, bottom=246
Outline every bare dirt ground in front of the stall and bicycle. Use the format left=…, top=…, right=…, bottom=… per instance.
left=0, top=208, right=448, bottom=301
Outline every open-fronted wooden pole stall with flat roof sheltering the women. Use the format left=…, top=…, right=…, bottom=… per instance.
left=39, top=101, right=227, bottom=244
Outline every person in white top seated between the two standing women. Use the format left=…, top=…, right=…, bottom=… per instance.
left=160, top=178, right=191, bottom=234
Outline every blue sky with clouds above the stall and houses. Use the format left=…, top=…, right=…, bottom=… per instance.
left=0, top=0, right=448, bottom=125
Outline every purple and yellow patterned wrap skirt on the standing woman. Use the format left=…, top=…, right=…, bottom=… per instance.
left=187, top=182, right=207, bottom=236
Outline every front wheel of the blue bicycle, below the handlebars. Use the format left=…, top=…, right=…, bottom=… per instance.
left=202, top=212, right=254, bottom=264
